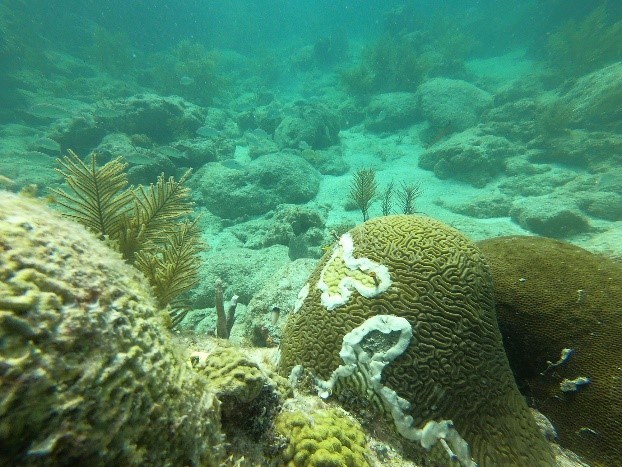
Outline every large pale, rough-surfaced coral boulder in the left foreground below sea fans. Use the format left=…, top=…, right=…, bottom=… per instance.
left=0, top=192, right=222, bottom=465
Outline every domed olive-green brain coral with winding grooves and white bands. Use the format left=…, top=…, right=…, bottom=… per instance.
left=279, top=215, right=554, bottom=466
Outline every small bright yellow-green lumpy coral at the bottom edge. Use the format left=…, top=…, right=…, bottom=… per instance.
left=275, top=409, right=369, bottom=467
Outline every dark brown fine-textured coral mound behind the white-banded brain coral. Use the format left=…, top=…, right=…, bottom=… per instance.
left=479, top=237, right=622, bottom=465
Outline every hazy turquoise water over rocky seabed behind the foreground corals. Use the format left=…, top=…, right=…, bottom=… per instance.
left=0, top=0, right=622, bottom=464
